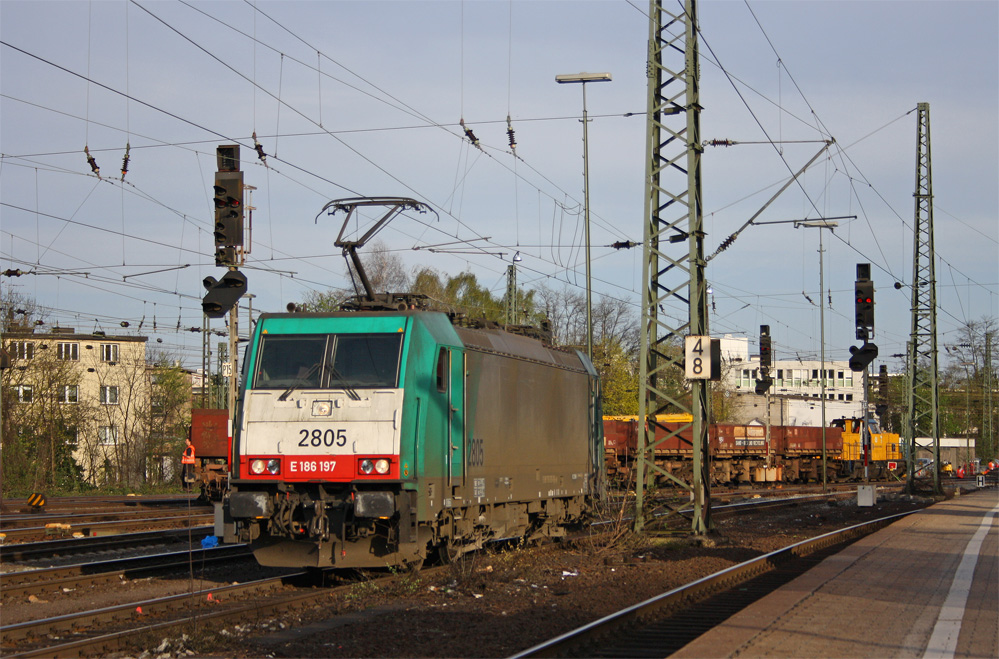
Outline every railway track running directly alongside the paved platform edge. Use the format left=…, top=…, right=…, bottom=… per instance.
left=515, top=513, right=911, bottom=658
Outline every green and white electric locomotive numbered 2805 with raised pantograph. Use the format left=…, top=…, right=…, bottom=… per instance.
left=223, top=200, right=603, bottom=568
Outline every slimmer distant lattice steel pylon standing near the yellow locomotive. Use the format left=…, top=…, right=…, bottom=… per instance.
left=905, top=103, right=940, bottom=492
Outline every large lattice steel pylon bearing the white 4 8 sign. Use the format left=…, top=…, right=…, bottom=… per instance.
left=635, top=0, right=712, bottom=533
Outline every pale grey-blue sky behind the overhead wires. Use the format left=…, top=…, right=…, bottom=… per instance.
left=0, top=0, right=999, bottom=372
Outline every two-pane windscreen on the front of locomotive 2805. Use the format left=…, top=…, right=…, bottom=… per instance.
left=253, top=334, right=402, bottom=389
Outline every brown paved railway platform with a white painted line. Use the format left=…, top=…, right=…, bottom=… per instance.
left=671, top=489, right=999, bottom=659
